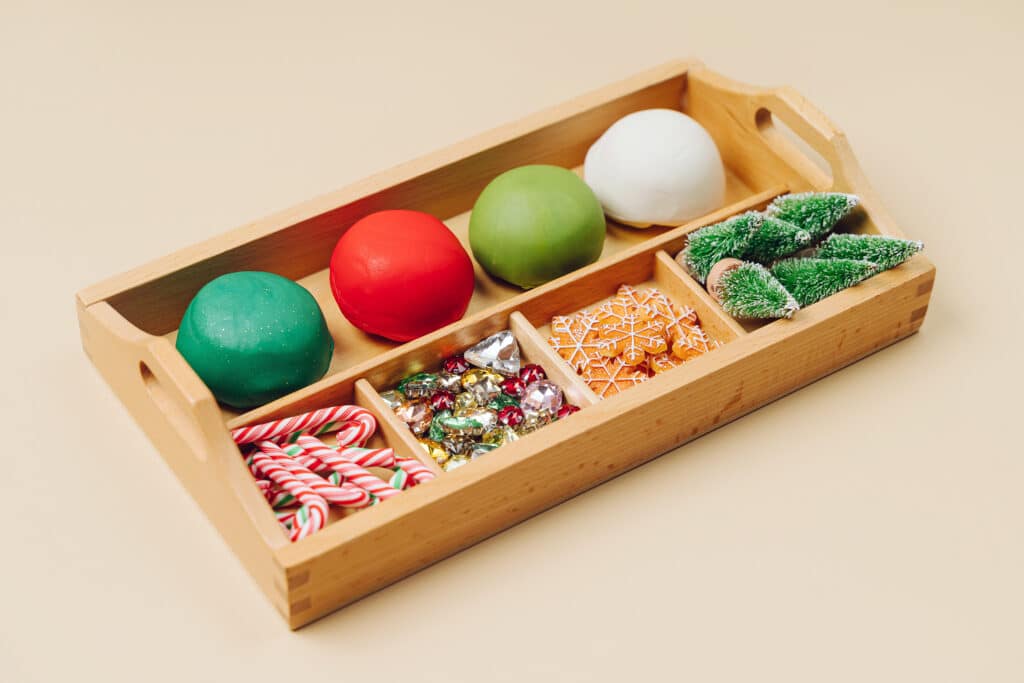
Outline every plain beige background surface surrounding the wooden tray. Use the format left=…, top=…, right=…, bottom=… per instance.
left=0, top=0, right=1024, bottom=683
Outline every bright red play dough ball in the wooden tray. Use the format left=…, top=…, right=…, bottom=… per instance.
left=331, top=210, right=474, bottom=341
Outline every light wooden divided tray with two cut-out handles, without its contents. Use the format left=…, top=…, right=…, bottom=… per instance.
left=77, top=61, right=935, bottom=628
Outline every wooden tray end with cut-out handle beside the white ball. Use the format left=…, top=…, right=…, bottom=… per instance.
left=687, top=66, right=902, bottom=237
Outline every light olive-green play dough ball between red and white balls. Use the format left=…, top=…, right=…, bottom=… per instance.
left=469, top=166, right=604, bottom=288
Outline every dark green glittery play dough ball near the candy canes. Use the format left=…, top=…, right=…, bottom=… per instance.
left=177, top=271, right=334, bottom=409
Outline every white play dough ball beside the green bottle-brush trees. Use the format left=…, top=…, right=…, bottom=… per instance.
left=584, top=110, right=725, bottom=227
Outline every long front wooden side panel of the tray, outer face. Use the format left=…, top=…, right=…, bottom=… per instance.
left=279, top=257, right=935, bottom=628
